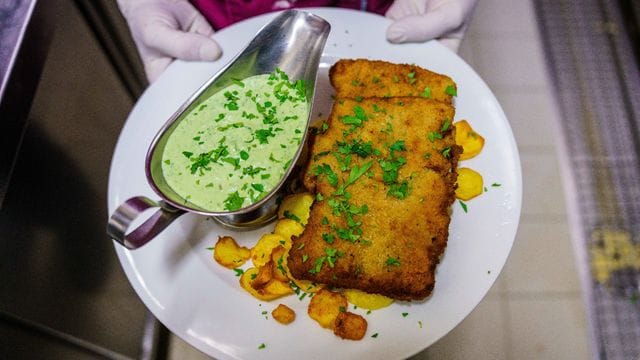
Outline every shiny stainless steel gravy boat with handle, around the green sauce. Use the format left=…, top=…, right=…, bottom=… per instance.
left=107, top=10, right=331, bottom=249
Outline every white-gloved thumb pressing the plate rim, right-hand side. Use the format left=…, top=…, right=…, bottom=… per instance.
left=387, top=9, right=464, bottom=43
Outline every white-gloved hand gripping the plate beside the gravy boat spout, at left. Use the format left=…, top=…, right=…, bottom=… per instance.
left=118, top=0, right=222, bottom=82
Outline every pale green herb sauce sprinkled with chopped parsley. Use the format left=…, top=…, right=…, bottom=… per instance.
left=161, top=69, right=310, bottom=212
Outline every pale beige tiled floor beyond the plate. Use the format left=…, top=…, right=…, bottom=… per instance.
left=169, top=0, right=590, bottom=360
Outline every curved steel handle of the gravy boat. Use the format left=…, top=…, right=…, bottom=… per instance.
left=107, top=196, right=185, bottom=250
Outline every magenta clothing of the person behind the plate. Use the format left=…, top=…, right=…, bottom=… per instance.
left=191, top=0, right=393, bottom=30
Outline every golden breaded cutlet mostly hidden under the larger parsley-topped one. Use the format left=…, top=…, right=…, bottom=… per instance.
left=329, top=59, right=456, bottom=104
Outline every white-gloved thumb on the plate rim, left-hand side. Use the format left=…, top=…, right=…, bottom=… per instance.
left=143, top=26, right=222, bottom=61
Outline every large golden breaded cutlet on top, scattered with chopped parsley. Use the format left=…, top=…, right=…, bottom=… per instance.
left=288, top=97, right=460, bottom=300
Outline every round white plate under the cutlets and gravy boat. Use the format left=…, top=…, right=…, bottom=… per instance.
left=109, top=8, right=522, bottom=359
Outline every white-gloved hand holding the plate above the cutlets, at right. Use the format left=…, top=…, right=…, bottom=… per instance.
left=385, top=0, right=477, bottom=51
